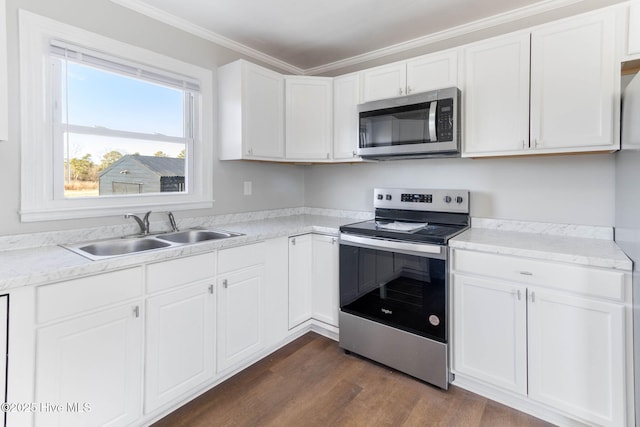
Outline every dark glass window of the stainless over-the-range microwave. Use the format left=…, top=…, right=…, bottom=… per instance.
left=360, top=103, right=429, bottom=148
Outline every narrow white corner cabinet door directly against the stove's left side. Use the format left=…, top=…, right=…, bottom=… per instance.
left=311, top=234, right=340, bottom=327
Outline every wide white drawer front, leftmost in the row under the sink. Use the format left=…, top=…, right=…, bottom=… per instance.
left=36, top=267, right=142, bottom=323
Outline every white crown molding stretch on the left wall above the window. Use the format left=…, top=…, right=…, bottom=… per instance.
left=110, top=0, right=305, bottom=75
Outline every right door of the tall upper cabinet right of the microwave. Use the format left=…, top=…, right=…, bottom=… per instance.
left=531, top=11, right=619, bottom=151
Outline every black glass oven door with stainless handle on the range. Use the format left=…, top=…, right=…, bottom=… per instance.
left=340, top=233, right=448, bottom=343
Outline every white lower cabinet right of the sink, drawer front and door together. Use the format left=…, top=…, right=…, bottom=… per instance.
left=216, top=244, right=265, bottom=372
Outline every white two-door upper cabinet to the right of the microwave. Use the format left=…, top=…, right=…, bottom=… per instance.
left=462, top=9, right=619, bottom=157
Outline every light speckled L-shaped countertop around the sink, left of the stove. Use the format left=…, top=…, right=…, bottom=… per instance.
left=0, top=214, right=366, bottom=291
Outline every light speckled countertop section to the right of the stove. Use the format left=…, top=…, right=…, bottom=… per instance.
left=449, top=218, right=633, bottom=271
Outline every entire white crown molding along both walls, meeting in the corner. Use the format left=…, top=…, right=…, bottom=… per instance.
left=110, top=0, right=600, bottom=75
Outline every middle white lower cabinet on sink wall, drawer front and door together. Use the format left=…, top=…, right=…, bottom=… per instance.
left=144, top=252, right=215, bottom=414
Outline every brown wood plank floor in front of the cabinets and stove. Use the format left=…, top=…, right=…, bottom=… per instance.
left=154, top=332, right=551, bottom=427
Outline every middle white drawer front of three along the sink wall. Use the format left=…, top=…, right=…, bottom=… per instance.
left=147, top=252, right=216, bottom=293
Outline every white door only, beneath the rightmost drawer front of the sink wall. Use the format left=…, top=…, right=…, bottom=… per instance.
left=217, top=264, right=264, bottom=372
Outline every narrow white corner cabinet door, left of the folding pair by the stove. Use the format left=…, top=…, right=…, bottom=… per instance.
left=289, top=234, right=313, bottom=329
